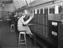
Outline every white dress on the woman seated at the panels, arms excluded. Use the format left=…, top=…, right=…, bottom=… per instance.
left=17, top=16, right=32, bottom=34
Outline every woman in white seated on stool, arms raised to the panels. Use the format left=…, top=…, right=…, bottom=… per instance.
left=17, top=10, right=34, bottom=35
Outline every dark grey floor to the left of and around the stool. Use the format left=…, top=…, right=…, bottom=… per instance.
left=0, top=22, right=39, bottom=48
